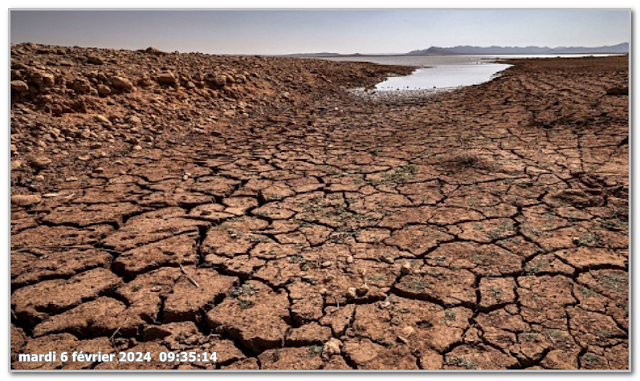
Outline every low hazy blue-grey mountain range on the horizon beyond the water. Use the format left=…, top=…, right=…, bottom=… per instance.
left=288, top=42, right=629, bottom=57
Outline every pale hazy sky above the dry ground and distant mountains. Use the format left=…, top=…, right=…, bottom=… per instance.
left=10, top=10, right=630, bottom=54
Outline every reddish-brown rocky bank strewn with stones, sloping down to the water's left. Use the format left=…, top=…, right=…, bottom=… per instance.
left=11, top=43, right=411, bottom=193
